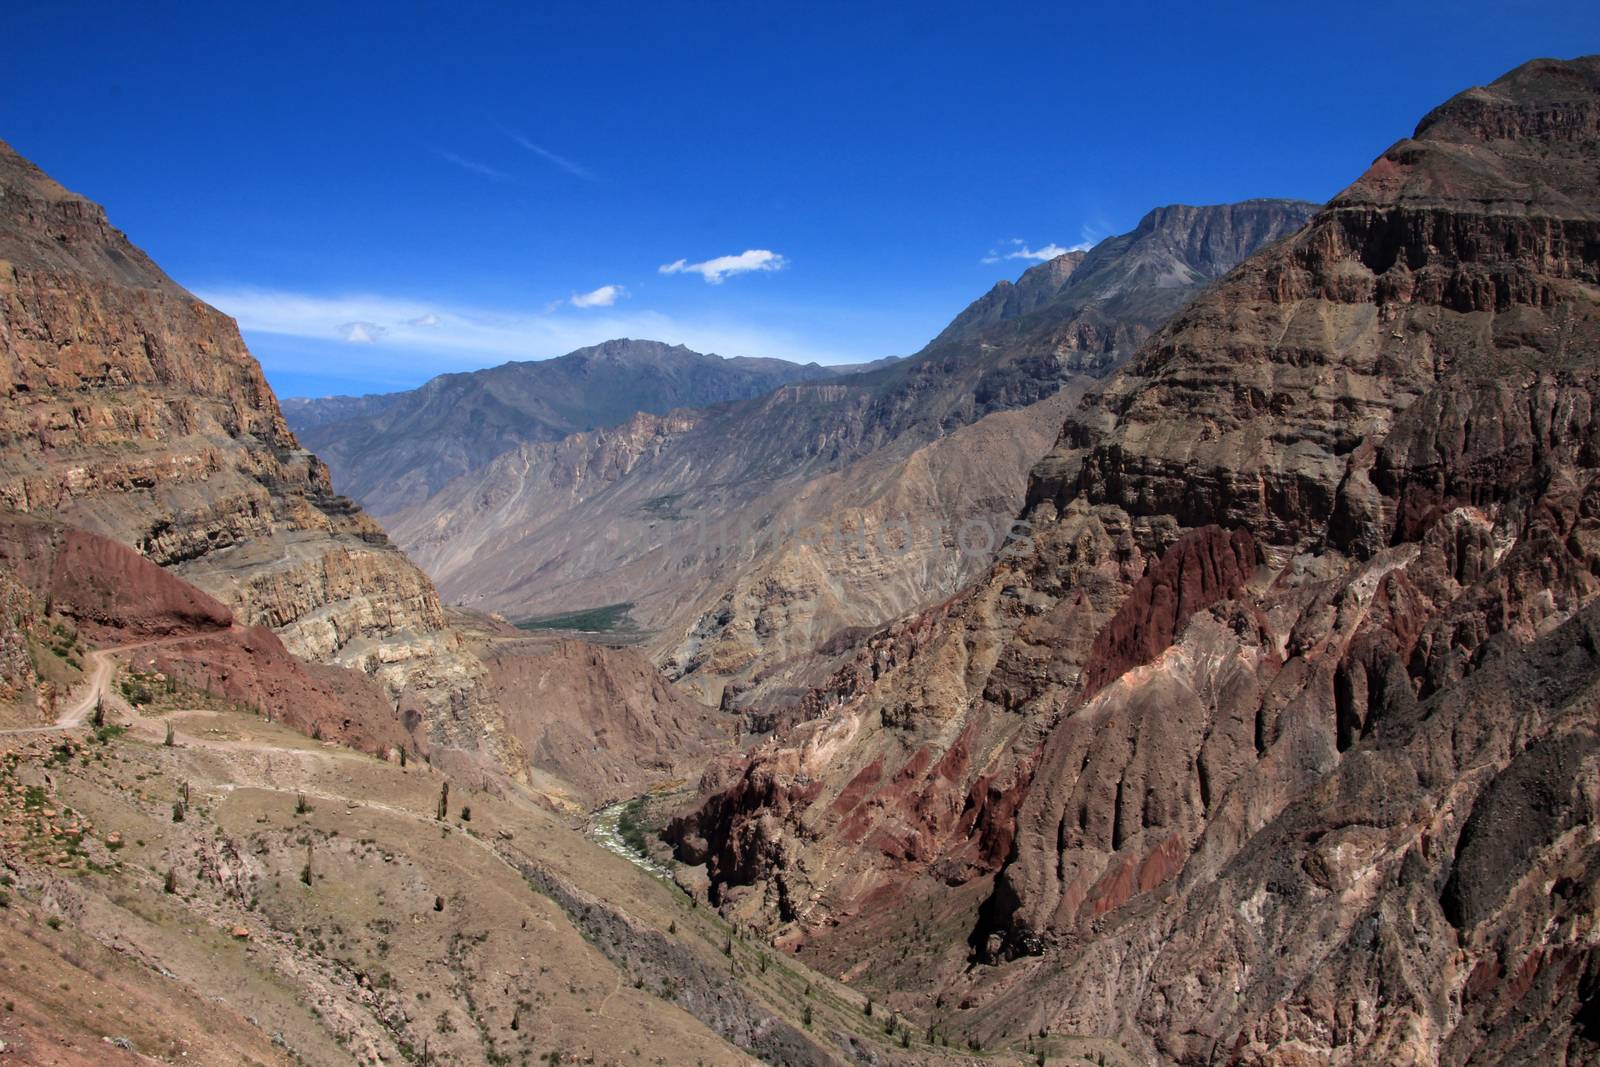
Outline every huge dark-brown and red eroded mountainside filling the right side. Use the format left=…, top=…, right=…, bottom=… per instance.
left=675, top=58, right=1600, bottom=1064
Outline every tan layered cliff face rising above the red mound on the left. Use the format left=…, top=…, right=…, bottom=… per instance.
left=0, top=137, right=443, bottom=681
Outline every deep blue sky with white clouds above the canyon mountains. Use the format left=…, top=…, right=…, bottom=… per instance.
left=9, top=0, right=1600, bottom=395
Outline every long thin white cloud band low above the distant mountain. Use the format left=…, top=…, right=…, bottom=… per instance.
left=197, top=286, right=851, bottom=369
